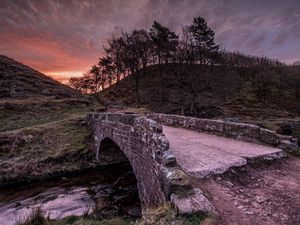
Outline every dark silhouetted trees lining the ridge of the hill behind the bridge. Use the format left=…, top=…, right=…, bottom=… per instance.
left=69, top=17, right=290, bottom=110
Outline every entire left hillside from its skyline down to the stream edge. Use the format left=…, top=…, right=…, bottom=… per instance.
left=0, top=56, right=100, bottom=186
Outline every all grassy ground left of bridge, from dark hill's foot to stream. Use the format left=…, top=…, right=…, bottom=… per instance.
left=0, top=94, right=104, bottom=186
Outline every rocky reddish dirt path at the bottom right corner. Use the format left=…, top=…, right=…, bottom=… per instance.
left=194, top=157, right=300, bottom=225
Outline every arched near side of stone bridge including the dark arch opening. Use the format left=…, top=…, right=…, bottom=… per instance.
left=87, top=113, right=169, bottom=208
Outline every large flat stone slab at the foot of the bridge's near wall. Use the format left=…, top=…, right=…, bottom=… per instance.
left=171, top=188, right=215, bottom=215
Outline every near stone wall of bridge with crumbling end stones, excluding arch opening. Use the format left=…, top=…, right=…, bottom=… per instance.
left=86, top=113, right=202, bottom=211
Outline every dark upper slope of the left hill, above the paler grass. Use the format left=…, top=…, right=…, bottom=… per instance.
left=0, top=55, right=84, bottom=98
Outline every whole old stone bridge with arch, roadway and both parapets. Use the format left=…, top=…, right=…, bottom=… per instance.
left=87, top=113, right=298, bottom=214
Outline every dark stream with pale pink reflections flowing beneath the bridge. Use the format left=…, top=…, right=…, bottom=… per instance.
left=0, top=164, right=140, bottom=225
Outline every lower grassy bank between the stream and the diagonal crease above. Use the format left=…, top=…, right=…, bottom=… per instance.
left=0, top=116, right=96, bottom=183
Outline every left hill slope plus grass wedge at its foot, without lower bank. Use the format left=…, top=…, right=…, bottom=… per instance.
left=0, top=56, right=99, bottom=132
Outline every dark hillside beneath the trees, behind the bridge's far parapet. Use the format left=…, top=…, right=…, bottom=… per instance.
left=101, top=65, right=300, bottom=135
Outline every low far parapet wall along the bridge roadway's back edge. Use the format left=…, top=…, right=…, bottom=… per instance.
left=148, top=113, right=299, bottom=152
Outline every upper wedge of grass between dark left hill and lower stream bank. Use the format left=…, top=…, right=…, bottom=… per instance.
left=0, top=97, right=99, bottom=132
